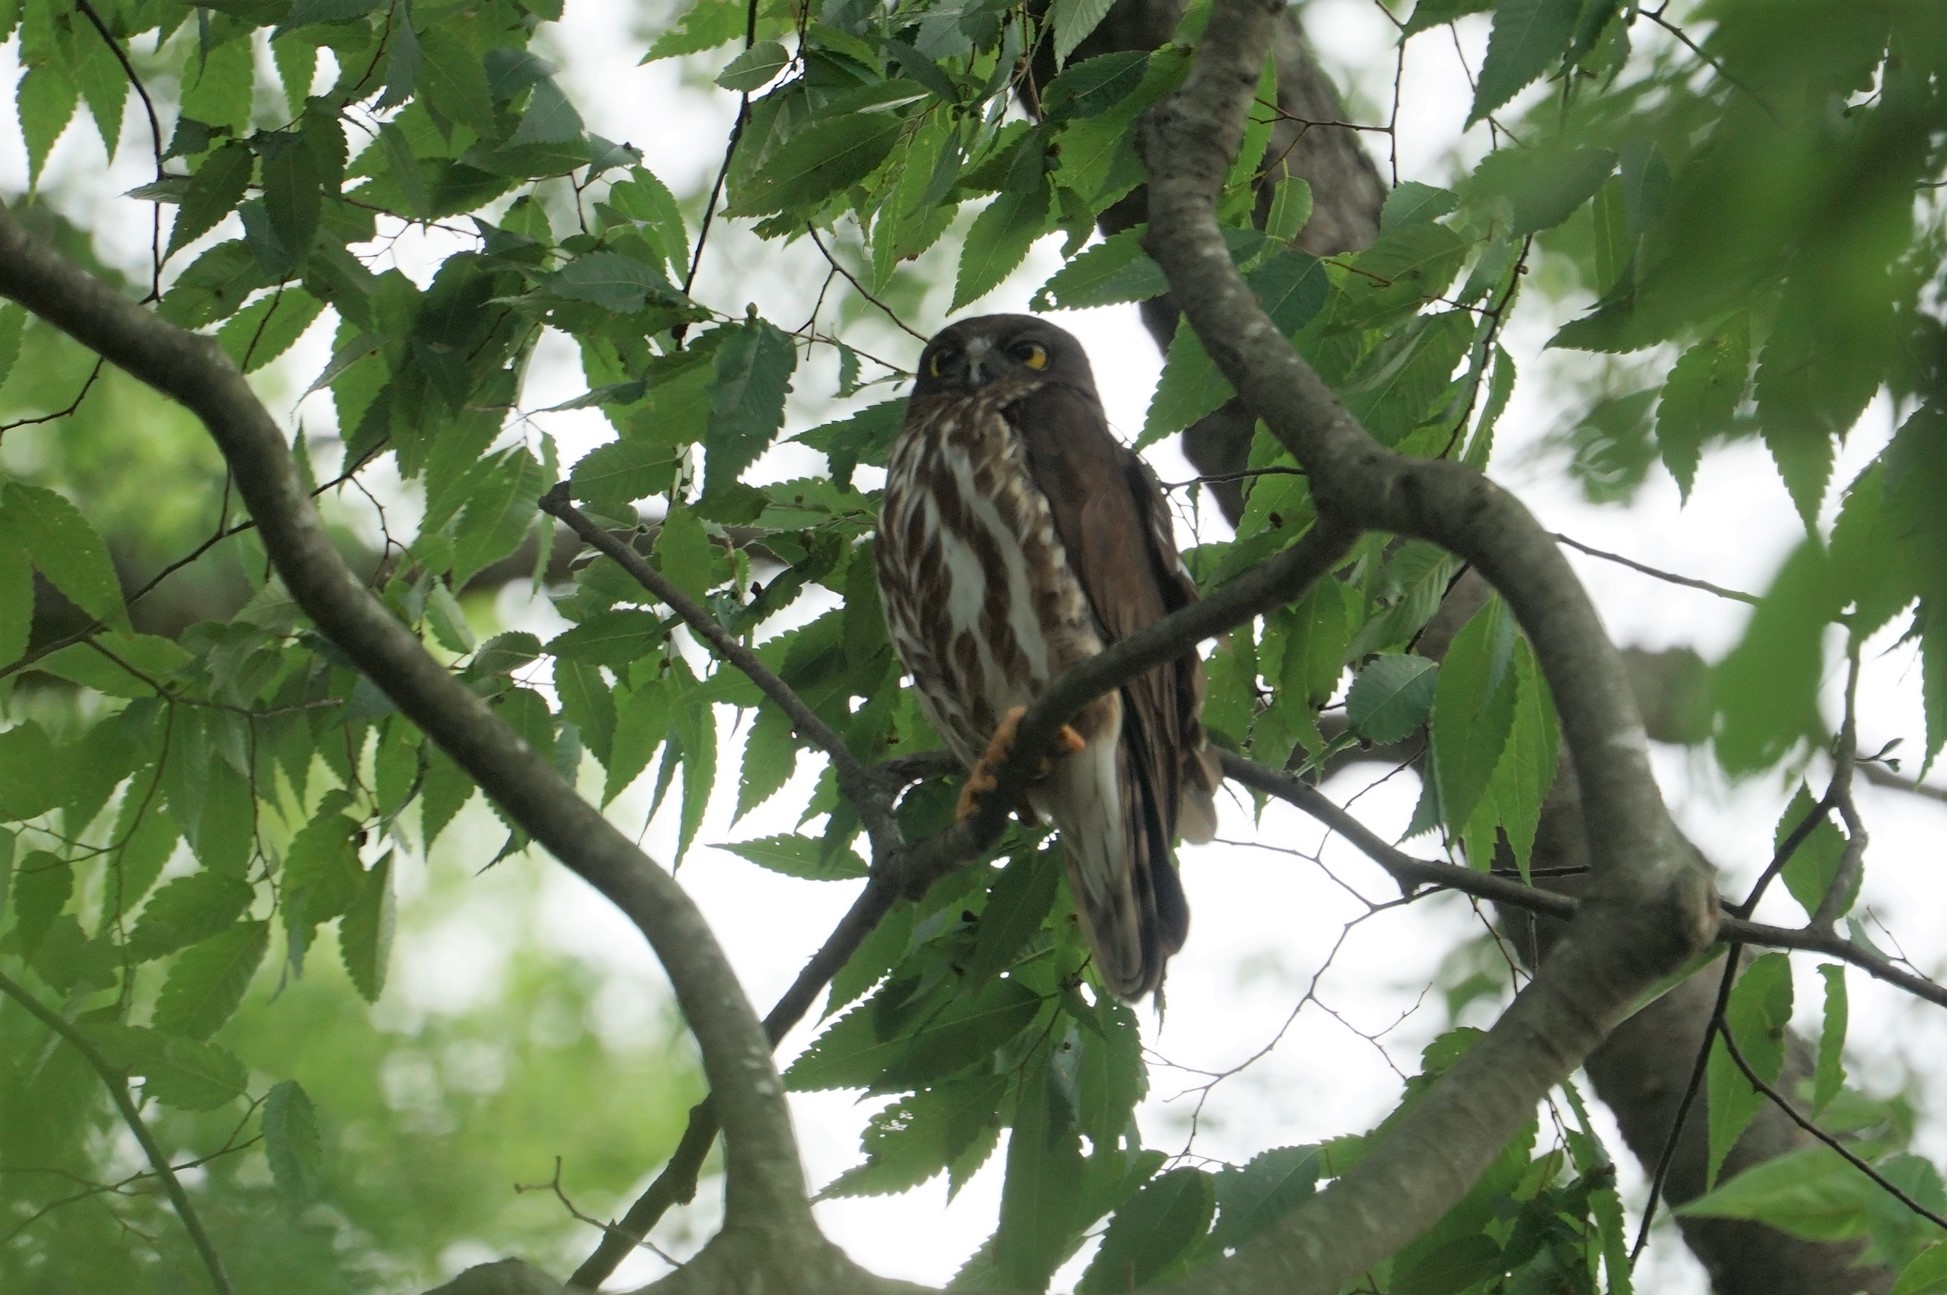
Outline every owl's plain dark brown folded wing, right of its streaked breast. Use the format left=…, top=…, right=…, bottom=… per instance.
left=1009, top=384, right=1217, bottom=985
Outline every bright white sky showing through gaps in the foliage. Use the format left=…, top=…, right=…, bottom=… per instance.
left=0, top=0, right=1947, bottom=1291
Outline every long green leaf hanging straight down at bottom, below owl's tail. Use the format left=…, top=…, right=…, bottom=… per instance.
left=989, top=1059, right=1084, bottom=1291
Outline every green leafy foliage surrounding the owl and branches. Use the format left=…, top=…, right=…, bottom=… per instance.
left=0, top=0, right=1947, bottom=1295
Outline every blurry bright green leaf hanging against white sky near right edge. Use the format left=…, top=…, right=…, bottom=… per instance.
left=1711, top=539, right=1836, bottom=775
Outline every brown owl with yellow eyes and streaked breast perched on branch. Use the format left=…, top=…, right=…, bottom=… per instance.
left=878, top=315, right=1221, bottom=1001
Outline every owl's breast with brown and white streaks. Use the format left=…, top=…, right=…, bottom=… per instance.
left=878, top=382, right=1102, bottom=765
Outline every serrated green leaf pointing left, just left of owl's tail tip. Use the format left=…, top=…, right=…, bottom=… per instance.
left=785, top=980, right=1042, bottom=1092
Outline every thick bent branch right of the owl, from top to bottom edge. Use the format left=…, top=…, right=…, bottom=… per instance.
left=1143, top=0, right=1715, bottom=1291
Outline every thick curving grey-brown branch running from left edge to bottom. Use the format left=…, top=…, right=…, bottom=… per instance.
left=0, top=210, right=816, bottom=1237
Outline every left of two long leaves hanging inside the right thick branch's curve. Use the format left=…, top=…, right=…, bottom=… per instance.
left=1433, top=598, right=1517, bottom=829
